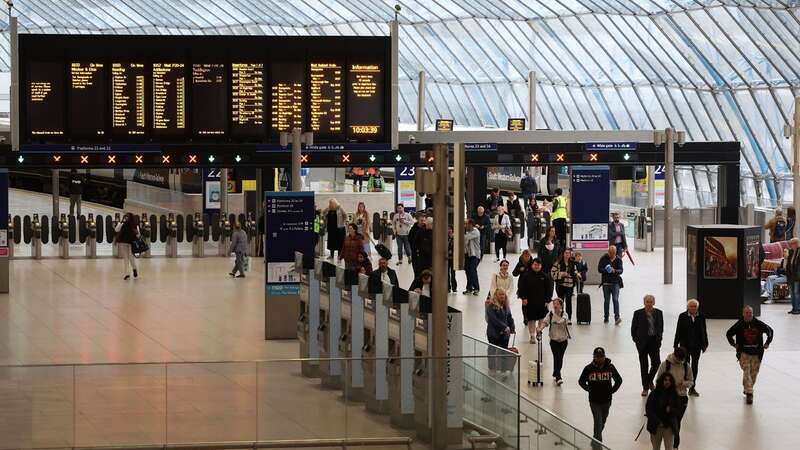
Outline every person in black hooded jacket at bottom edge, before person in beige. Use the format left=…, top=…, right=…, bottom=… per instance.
left=644, top=372, right=680, bottom=450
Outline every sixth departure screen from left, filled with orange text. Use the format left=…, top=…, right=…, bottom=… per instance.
left=231, top=63, right=265, bottom=136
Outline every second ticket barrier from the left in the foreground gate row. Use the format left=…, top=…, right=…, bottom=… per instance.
left=318, top=262, right=342, bottom=389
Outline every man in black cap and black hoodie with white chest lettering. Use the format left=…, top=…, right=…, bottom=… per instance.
left=578, top=347, right=622, bottom=448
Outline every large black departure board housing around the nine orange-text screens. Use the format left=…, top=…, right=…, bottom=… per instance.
left=19, top=34, right=392, bottom=145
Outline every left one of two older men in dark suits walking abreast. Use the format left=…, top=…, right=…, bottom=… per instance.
left=631, top=294, right=664, bottom=397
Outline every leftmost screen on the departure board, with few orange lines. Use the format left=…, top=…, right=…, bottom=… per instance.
left=27, top=61, right=65, bottom=137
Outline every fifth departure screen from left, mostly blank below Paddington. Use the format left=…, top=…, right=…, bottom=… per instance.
left=191, top=63, right=223, bottom=136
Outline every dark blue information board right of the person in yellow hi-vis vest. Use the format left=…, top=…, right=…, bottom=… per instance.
left=571, top=166, right=611, bottom=249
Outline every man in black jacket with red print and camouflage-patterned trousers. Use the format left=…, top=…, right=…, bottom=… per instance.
left=725, top=306, right=773, bottom=405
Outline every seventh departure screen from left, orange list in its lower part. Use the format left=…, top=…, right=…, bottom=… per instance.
left=270, top=63, right=306, bottom=133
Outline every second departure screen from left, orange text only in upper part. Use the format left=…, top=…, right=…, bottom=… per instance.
left=69, top=62, right=108, bottom=137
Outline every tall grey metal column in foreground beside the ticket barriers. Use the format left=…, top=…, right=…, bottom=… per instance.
left=430, top=144, right=450, bottom=449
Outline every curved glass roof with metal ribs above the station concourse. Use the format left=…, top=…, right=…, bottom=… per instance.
left=0, top=0, right=800, bottom=205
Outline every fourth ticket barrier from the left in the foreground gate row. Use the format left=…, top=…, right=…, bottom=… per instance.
left=364, top=274, right=392, bottom=414
